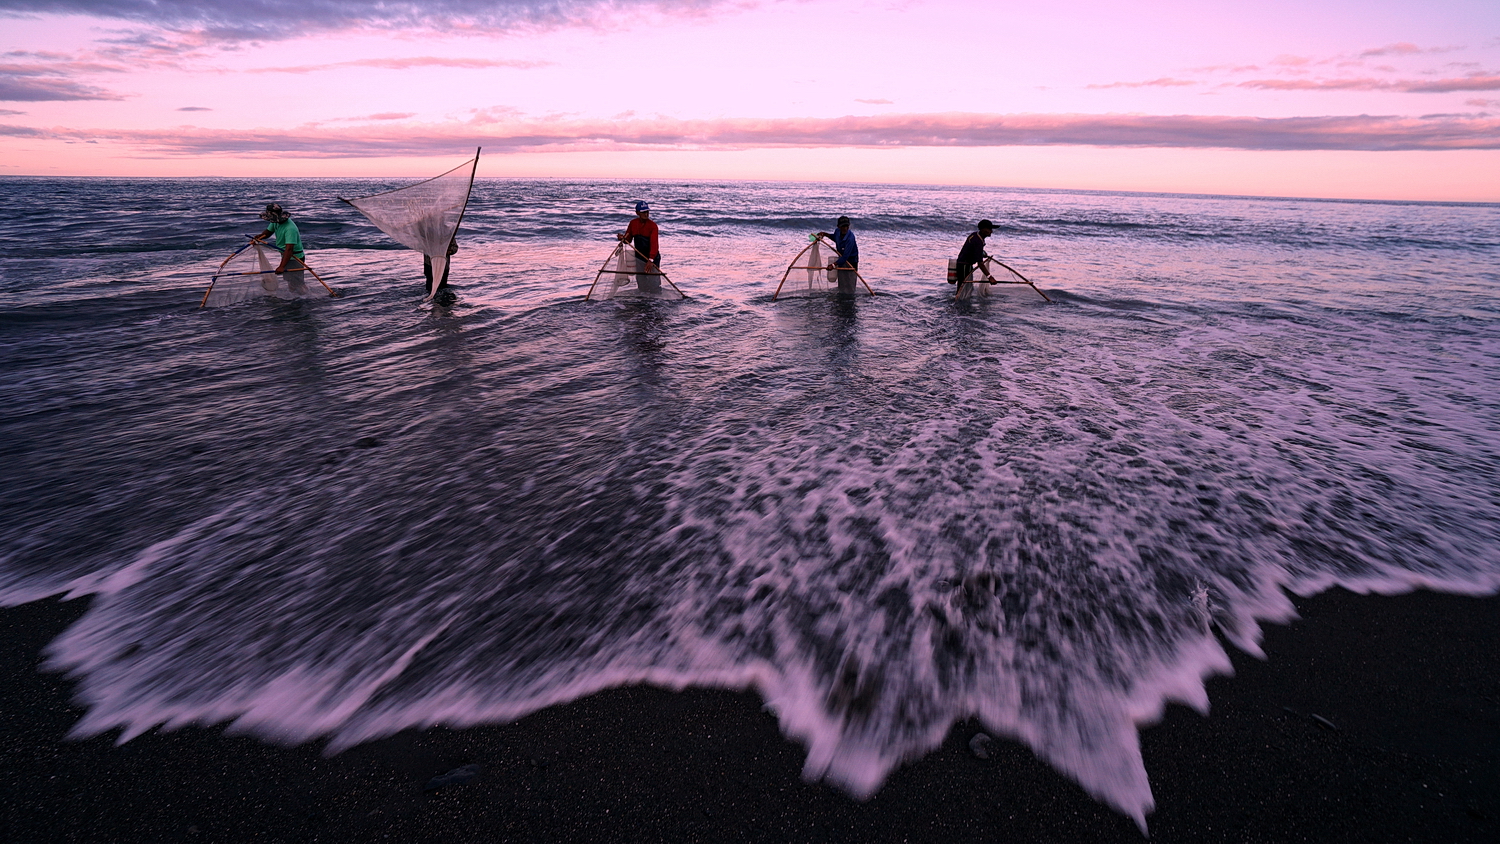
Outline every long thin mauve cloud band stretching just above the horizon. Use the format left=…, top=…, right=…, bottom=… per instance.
left=14, top=114, right=1500, bottom=159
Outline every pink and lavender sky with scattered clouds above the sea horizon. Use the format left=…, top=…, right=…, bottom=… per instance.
left=0, top=0, right=1500, bottom=201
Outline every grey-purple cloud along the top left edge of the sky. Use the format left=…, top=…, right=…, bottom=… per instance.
left=0, top=0, right=717, bottom=40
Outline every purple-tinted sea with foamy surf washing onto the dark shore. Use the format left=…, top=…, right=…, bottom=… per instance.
left=0, top=178, right=1500, bottom=819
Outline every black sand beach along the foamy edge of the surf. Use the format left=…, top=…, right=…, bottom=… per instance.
left=0, top=591, right=1500, bottom=843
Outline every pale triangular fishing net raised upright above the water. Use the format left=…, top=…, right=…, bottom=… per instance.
left=339, top=150, right=480, bottom=298
